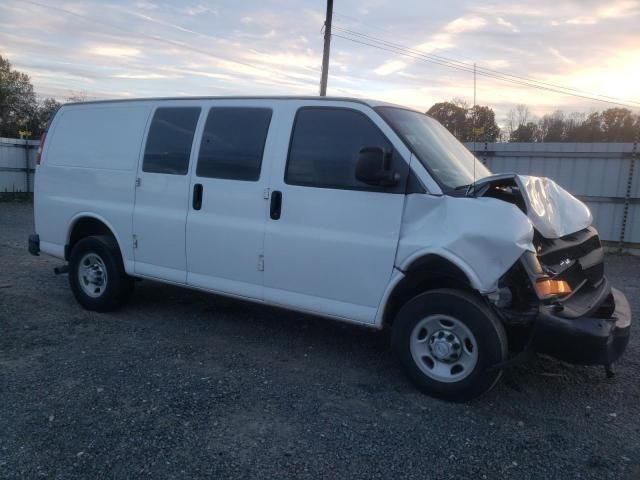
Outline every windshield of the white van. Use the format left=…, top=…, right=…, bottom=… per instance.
left=376, top=107, right=491, bottom=190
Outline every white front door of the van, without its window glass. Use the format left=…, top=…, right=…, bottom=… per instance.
left=264, top=101, right=410, bottom=323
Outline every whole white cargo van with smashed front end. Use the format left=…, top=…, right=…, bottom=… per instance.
left=29, top=97, right=631, bottom=400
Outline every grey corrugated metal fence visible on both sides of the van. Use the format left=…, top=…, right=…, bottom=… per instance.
left=0, top=138, right=640, bottom=248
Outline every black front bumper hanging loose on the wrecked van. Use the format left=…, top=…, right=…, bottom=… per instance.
left=532, top=288, right=631, bottom=365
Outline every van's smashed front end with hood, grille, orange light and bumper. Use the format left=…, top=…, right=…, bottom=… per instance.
left=475, top=175, right=631, bottom=373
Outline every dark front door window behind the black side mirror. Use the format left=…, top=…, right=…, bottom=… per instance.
left=285, top=107, right=393, bottom=190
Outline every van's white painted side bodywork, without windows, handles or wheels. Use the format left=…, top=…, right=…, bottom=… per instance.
left=35, top=98, right=544, bottom=327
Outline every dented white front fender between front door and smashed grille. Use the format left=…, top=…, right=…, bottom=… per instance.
left=396, top=195, right=535, bottom=293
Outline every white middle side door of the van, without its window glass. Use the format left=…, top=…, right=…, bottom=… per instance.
left=186, top=100, right=288, bottom=300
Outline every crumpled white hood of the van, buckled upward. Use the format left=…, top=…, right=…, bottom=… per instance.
left=475, top=174, right=593, bottom=239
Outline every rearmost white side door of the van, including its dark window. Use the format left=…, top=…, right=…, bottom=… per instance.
left=130, top=104, right=201, bottom=283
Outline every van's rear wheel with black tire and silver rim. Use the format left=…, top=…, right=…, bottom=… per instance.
left=69, top=235, right=134, bottom=312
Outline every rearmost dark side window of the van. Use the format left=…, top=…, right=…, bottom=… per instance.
left=142, top=107, right=200, bottom=175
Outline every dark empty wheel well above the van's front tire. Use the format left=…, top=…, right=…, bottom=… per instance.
left=382, top=255, right=474, bottom=326
